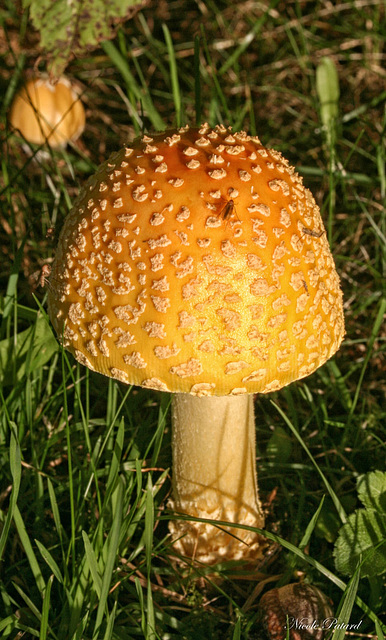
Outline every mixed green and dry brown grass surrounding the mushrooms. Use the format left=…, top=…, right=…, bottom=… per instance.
left=0, top=0, right=386, bottom=640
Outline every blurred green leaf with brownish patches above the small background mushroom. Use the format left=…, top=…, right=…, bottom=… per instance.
left=23, top=0, right=147, bottom=76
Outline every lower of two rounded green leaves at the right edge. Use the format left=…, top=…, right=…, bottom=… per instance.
left=334, top=509, right=386, bottom=577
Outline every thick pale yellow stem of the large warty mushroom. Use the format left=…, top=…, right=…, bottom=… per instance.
left=170, top=393, right=264, bottom=563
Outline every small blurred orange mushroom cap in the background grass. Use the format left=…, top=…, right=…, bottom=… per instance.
left=9, top=76, right=85, bottom=148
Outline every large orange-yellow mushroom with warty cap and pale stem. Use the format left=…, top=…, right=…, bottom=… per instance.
left=49, top=124, right=344, bottom=564
